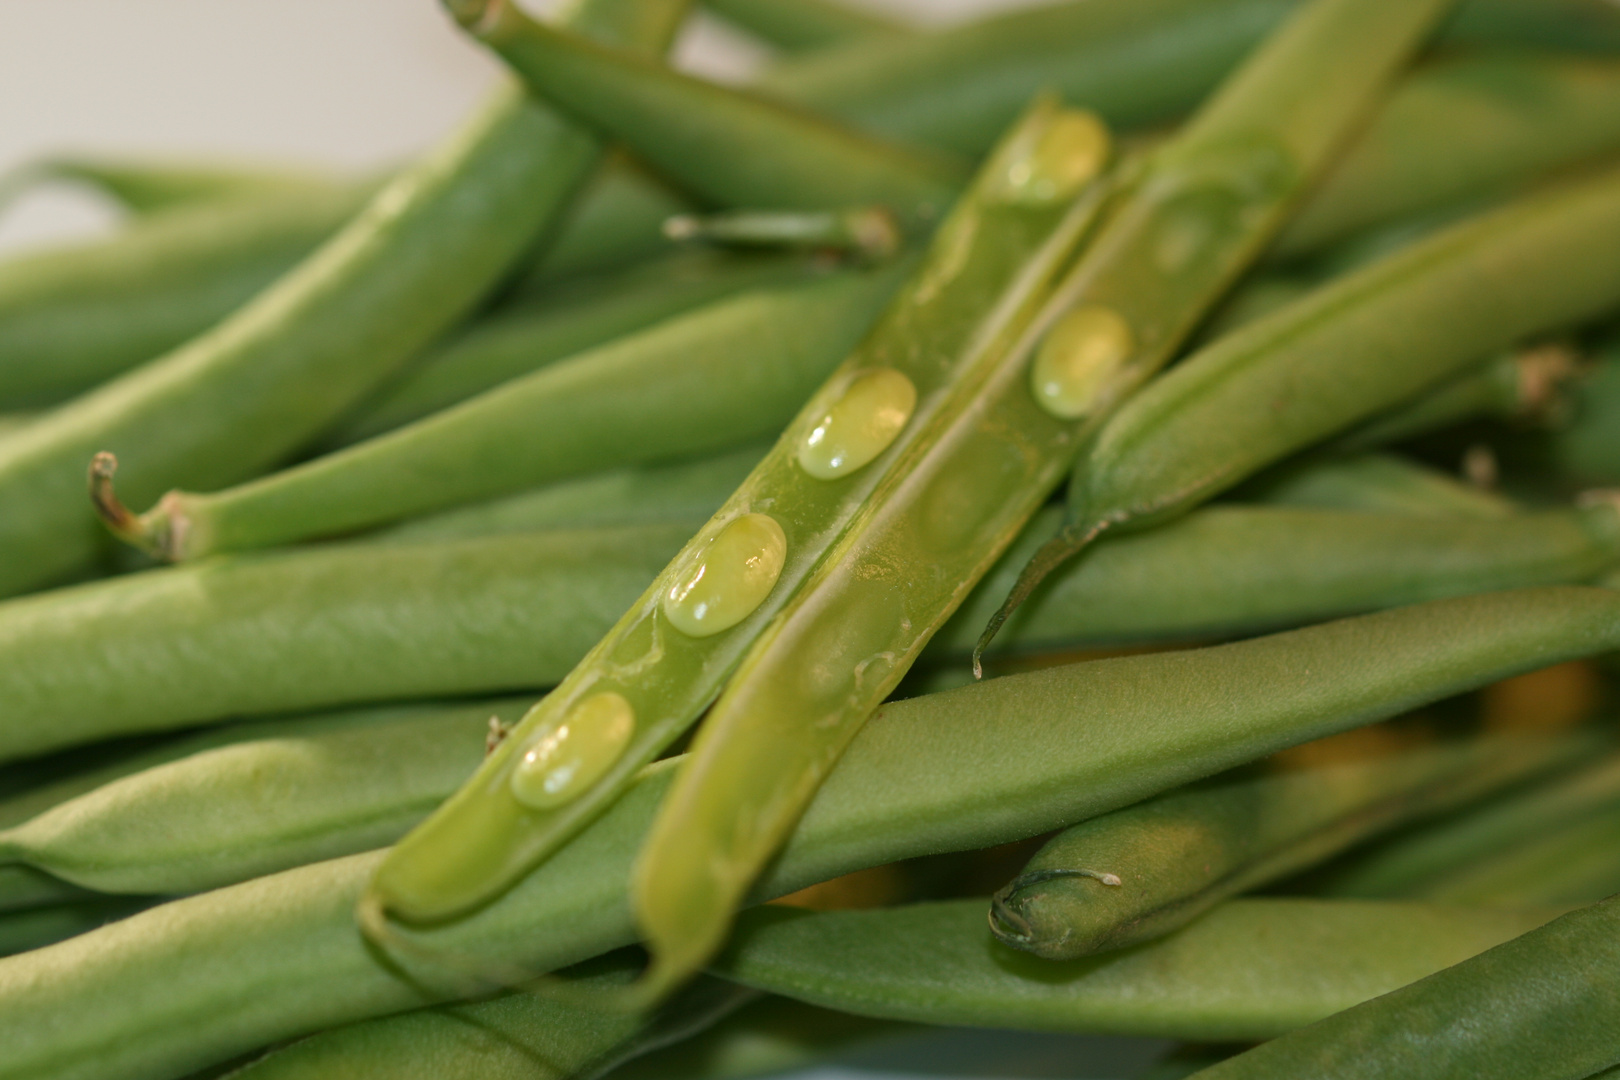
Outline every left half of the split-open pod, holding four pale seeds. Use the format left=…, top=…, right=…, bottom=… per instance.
left=368, top=100, right=1121, bottom=921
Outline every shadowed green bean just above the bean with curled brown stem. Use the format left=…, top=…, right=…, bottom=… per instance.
left=326, top=253, right=815, bottom=447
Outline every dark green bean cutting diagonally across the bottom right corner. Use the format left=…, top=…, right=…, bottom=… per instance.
left=1197, top=899, right=1620, bottom=1080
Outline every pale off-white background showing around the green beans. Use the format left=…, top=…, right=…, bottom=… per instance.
left=0, top=0, right=1163, bottom=1080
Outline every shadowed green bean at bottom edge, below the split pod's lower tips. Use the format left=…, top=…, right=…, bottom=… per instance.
left=230, top=954, right=755, bottom=1080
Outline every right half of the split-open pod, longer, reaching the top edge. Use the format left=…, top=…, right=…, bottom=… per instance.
left=633, top=0, right=1464, bottom=994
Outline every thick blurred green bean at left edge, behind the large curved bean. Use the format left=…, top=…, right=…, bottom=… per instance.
left=0, top=185, right=371, bottom=410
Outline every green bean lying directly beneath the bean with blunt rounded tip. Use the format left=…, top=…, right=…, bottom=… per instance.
left=716, top=899, right=1557, bottom=1042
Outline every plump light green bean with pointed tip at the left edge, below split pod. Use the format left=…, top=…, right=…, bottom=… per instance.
left=0, top=695, right=533, bottom=895
